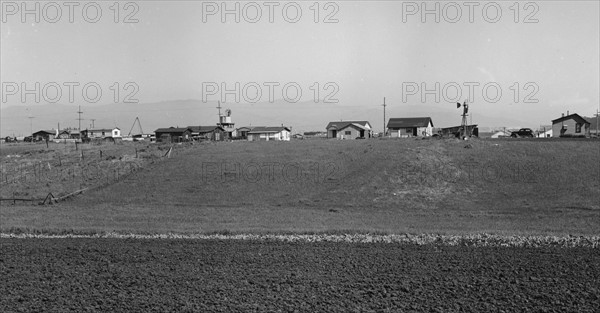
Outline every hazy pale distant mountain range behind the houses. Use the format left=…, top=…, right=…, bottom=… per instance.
left=0, top=99, right=537, bottom=137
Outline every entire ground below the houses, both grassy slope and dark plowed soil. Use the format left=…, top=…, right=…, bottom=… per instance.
left=0, top=139, right=600, bottom=312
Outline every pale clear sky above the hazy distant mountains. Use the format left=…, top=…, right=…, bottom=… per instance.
left=0, top=1, right=600, bottom=132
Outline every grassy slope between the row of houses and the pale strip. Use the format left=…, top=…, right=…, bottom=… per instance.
left=0, top=139, right=600, bottom=234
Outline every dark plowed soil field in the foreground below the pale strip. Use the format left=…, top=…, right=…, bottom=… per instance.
left=0, top=238, right=600, bottom=312
